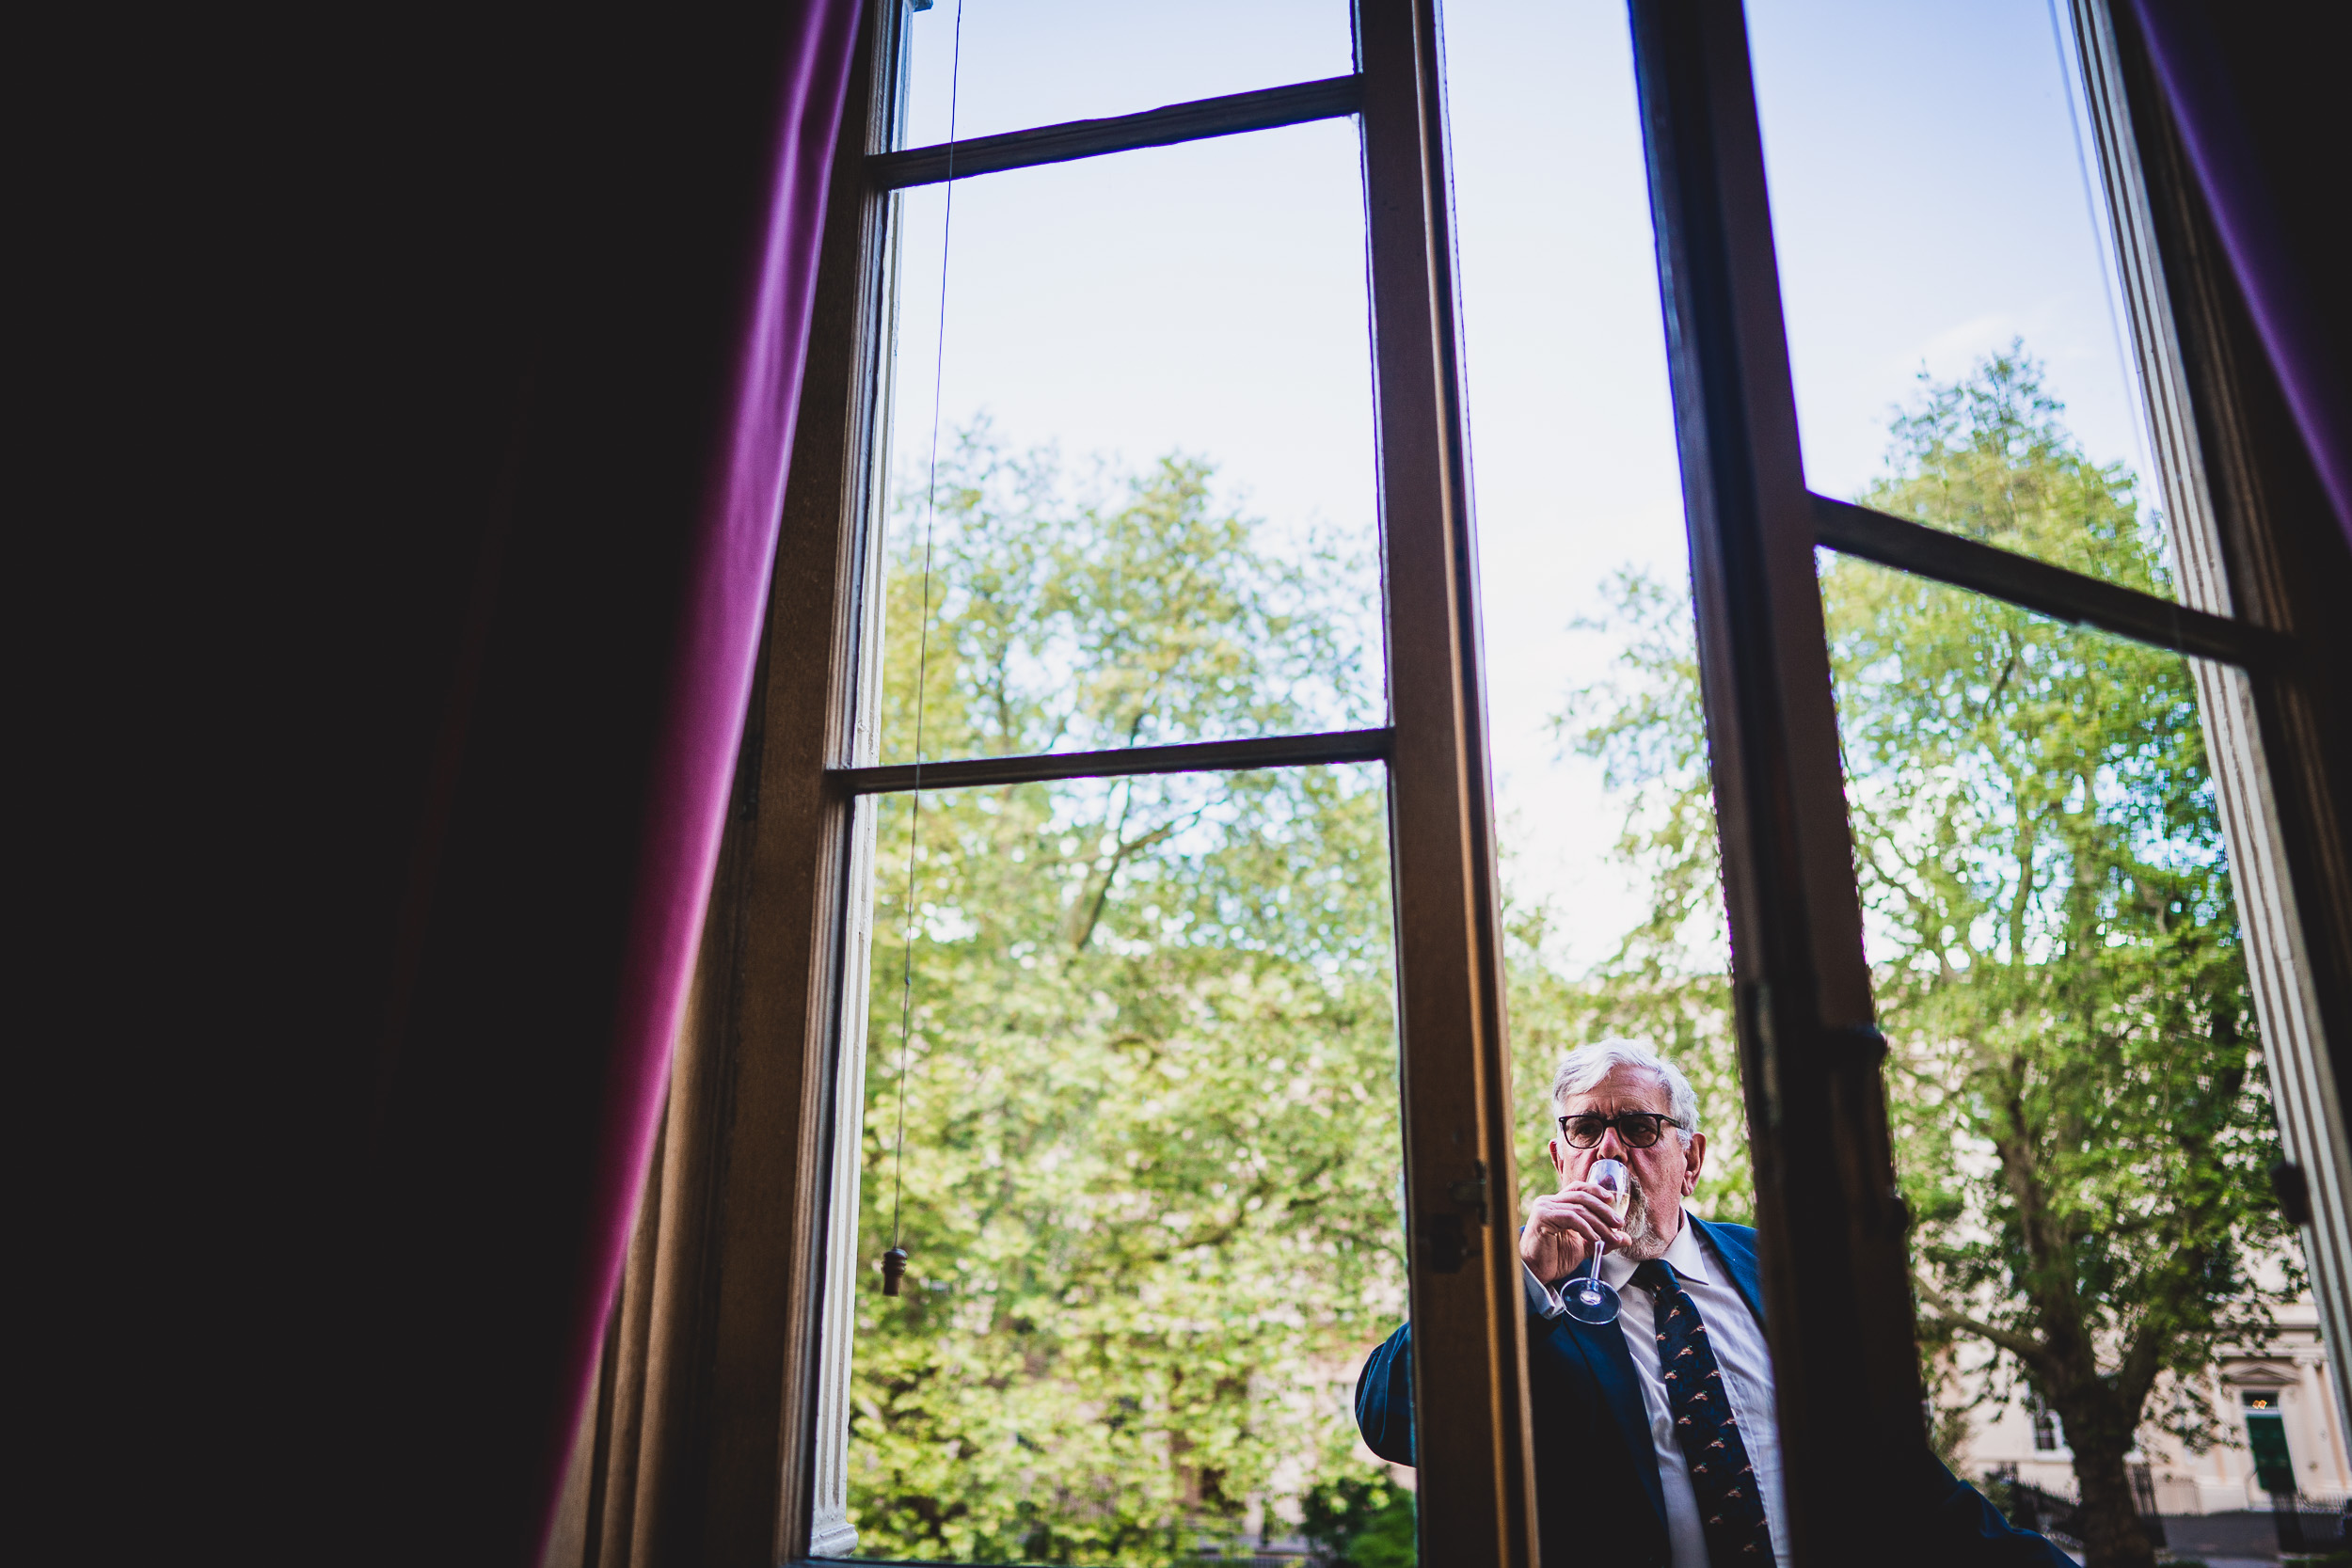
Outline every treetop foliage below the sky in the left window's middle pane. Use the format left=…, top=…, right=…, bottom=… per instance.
left=882, top=420, right=1378, bottom=762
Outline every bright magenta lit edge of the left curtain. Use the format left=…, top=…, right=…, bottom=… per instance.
left=541, top=0, right=859, bottom=1540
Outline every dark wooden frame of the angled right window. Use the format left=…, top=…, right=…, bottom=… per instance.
left=1632, top=0, right=2352, bottom=1561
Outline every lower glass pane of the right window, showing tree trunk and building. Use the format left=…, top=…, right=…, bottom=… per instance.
left=1820, top=557, right=2314, bottom=1561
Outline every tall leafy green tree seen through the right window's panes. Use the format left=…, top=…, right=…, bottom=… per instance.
left=1576, top=348, right=2300, bottom=1568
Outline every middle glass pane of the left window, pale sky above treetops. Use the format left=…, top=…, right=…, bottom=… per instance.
left=880, top=122, right=1386, bottom=762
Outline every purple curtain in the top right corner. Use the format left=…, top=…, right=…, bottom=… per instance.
left=2134, top=0, right=2352, bottom=543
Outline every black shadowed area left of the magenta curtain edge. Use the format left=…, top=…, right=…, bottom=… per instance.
left=19, top=5, right=847, bottom=1563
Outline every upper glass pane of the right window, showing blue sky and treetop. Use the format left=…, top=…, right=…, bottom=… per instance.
left=1748, top=0, right=2173, bottom=597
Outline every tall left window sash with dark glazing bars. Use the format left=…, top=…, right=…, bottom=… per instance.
left=812, top=5, right=1518, bottom=1561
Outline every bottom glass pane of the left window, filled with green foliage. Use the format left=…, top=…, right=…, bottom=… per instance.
left=850, top=767, right=1411, bottom=1563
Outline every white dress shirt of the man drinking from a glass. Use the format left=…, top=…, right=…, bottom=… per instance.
left=1519, top=1215, right=1788, bottom=1568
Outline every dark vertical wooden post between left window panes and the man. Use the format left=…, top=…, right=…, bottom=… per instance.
left=1358, top=0, right=1536, bottom=1568
